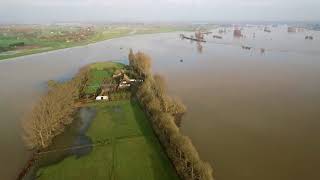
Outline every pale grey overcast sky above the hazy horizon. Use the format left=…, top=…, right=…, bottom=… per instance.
left=0, top=0, right=320, bottom=23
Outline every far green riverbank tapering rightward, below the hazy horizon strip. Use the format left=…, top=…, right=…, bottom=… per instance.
left=0, top=26, right=191, bottom=61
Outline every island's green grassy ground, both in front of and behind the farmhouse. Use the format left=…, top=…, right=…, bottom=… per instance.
left=36, top=62, right=179, bottom=180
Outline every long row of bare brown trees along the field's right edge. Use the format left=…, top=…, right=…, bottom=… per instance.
left=129, top=50, right=213, bottom=180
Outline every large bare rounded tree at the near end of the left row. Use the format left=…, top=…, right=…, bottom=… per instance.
left=23, top=85, right=75, bottom=149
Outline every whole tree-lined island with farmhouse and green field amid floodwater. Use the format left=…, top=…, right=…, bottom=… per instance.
left=18, top=50, right=213, bottom=180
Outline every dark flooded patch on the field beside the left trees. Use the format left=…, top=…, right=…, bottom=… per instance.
left=25, top=107, right=96, bottom=179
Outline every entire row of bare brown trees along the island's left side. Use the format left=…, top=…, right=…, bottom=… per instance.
left=22, top=67, right=89, bottom=150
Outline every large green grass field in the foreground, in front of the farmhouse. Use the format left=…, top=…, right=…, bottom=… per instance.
left=38, top=100, right=178, bottom=180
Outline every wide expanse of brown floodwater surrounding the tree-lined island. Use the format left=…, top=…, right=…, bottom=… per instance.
left=0, top=26, right=320, bottom=180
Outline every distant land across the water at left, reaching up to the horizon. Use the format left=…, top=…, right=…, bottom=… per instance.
left=0, top=25, right=191, bottom=60
